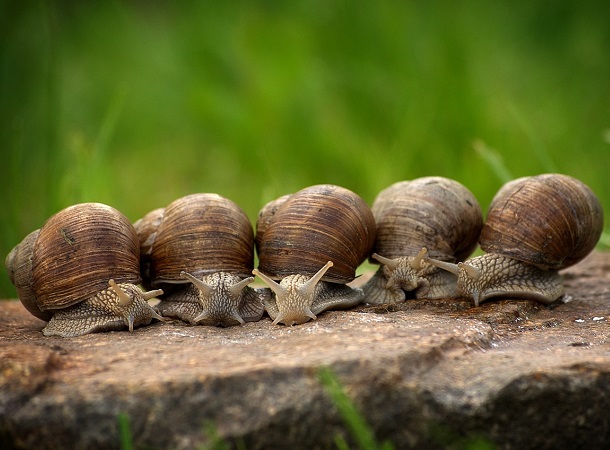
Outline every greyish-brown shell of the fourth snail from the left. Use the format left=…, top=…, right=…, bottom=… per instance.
left=371, top=177, right=483, bottom=261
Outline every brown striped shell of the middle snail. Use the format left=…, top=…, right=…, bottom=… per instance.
left=257, top=185, right=375, bottom=283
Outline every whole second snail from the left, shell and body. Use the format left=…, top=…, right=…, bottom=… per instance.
left=134, top=194, right=264, bottom=326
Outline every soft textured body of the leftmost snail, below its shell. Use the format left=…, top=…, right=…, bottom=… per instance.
left=42, top=280, right=164, bottom=337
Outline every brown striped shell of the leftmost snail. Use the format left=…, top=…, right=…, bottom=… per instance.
left=6, top=203, right=140, bottom=320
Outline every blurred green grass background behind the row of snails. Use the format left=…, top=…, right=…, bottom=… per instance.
left=0, top=0, right=610, bottom=297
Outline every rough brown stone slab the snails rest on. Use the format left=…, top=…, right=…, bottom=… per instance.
left=0, top=253, right=610, bottom=449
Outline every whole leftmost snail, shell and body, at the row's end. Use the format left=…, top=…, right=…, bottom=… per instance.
left=6, top=203, right=163, bottom=337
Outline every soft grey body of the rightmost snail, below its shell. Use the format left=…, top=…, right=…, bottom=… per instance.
left=435, top=253, right=564, bottom=306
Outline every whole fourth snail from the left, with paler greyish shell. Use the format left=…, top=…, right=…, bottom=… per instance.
left=363, top=177, right=483, bottom=304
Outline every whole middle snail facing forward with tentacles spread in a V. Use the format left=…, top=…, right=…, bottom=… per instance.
left=252, top=184, right=375, bottom=326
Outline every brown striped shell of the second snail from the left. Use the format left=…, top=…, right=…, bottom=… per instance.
left=144, top=194, right=254, bottom=285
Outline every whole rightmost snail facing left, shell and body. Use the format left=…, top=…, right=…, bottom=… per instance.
left=430, top=174, right=603, bottom=306
